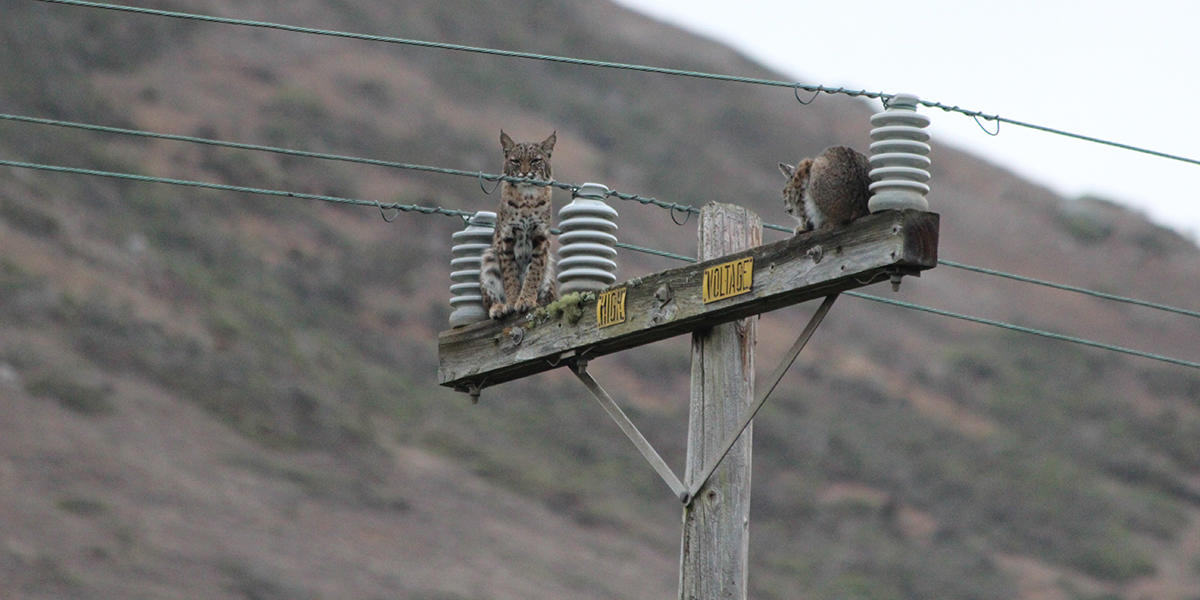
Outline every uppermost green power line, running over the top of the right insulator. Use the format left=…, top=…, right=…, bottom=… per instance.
left=38, top=0, right=1200, bottom=166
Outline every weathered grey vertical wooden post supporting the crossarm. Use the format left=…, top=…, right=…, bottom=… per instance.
left=679, top=204, right=762, bottom=600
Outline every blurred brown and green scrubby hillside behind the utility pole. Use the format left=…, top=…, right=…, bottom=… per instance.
left=0, top=0, right=1200, bottom=600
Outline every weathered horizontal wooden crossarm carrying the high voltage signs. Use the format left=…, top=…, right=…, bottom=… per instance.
left=438, top=210, right=938, bottom=390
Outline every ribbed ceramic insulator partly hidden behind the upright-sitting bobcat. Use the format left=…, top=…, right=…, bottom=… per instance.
left=450, top=211, right=496, bottom=328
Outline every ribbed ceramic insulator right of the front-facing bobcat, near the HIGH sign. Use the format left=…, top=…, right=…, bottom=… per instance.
left=558, top=184, right=617, bottom=295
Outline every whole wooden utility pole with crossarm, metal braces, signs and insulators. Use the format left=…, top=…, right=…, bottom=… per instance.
left=438, top=94, right=940, bottom=600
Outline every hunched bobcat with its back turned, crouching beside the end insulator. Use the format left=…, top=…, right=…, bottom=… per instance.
left=779, top=146, right=871, bottom=233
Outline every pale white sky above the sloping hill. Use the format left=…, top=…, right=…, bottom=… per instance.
left=617, top=0, right=1200, bottom=240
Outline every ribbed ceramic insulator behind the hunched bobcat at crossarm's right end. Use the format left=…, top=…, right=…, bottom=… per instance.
left=868, top=94, right=930, bottom=212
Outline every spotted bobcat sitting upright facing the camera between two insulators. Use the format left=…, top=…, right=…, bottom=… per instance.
left=479, top=131, right=558, bottom=319
